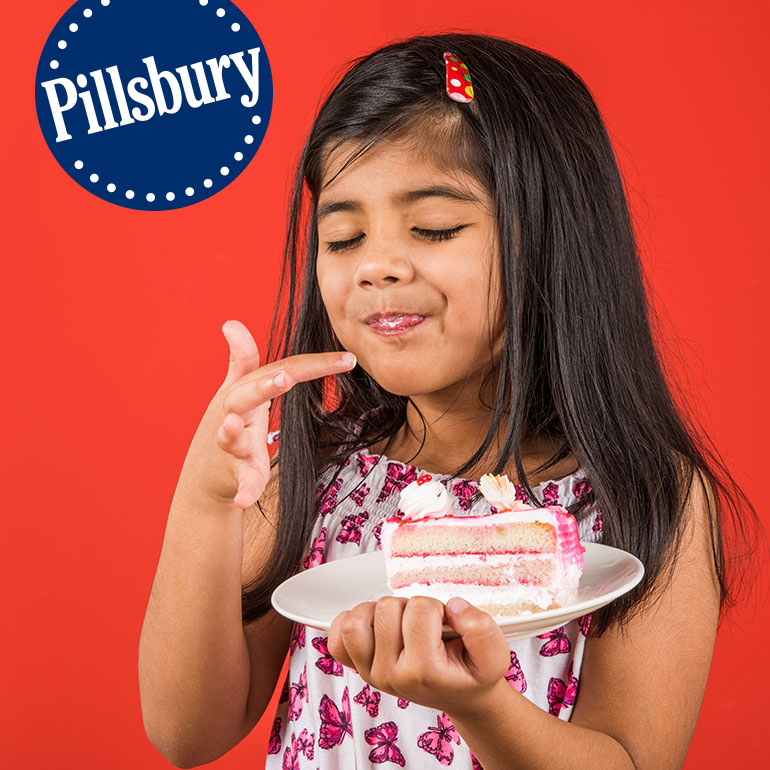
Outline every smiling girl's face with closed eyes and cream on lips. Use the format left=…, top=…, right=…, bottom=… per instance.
left=316, top=136, right=503, bottom=396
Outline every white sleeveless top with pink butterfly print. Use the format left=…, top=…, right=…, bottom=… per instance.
left=265, top=431, right=602, bottom=770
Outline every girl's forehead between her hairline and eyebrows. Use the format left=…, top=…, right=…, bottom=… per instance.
left=316, top=141, right=491, bottom=222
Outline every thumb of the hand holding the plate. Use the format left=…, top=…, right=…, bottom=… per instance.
left=446, top=596, right=510, bottom=682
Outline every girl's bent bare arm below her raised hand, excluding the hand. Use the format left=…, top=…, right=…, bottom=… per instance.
left=139, top=466, right=293, bottom=767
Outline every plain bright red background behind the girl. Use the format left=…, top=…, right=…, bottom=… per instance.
left=0, top=0, right=770, bottom=770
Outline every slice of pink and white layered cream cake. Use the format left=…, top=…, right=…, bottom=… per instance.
left=381, top=474, right=585, bottom=616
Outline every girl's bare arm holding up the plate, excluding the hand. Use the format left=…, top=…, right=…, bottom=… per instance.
left=448, top=468, right=719, bottom=770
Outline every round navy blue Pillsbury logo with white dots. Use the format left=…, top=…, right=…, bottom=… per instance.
left=35, top=0, right=273, bottom=211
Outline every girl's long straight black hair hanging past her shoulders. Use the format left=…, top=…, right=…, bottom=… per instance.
left=243, top=33, right=759, bottom=633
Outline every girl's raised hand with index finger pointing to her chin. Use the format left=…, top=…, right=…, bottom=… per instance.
left=174, top=321, right=356, bottom=508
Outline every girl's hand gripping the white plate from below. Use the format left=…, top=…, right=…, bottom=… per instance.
left=329, top=596, right=511, bottom=713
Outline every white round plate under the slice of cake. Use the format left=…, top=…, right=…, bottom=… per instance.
left=272, top=543, right=644, bottom=641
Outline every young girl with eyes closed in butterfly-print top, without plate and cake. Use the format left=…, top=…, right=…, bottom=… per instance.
left=139, top=34, right=753, bottom=770
